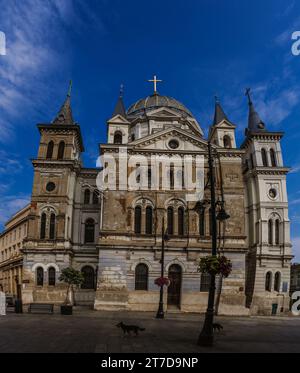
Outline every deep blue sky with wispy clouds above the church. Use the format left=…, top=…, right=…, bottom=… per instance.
left=0, top=0, right=300, bottom=261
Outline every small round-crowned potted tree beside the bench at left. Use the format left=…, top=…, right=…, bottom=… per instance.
left=59, top=267, right=84, bottom=315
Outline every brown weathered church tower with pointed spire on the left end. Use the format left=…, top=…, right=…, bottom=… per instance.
left=23, top=83, right=84, bottom=303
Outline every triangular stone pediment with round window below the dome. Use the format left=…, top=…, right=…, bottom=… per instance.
left=130, top=128, right=207, bottom=152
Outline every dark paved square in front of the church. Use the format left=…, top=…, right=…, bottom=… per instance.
left=0, top=310, right=300, bottom=353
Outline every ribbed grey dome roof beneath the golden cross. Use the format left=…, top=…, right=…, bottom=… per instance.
left=127, top=94, right=193, bottom=117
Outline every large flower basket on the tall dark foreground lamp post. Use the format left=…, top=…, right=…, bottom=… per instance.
left=198, top=256, right=232, bottom=277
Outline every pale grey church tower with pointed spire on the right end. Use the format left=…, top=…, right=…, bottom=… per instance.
left=241, top=89, right=292, bottom=314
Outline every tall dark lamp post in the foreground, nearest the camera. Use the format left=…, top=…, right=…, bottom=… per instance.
left=198, top=141, right=229, bottom=346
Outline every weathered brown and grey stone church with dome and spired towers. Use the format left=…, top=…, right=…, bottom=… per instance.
left=18, top=79, right=292, bottom=315
